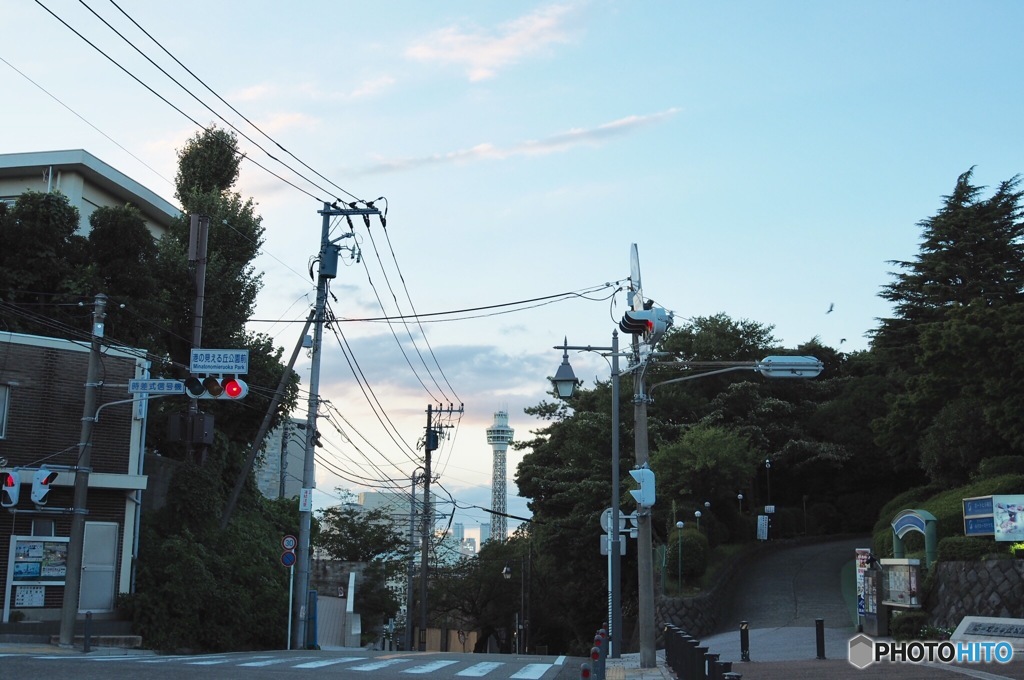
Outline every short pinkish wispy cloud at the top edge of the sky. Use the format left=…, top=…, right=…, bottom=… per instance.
left=406, top=4, right=578, bottom=81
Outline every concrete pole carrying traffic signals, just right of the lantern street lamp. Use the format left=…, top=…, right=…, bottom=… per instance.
left=633, top=335, right=657, bottom=668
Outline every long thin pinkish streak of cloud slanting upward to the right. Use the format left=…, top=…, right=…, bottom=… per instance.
left=359, top=108, right=679, bottom=175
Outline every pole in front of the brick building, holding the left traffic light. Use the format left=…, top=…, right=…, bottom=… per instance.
left=58, top=293, right=106, bottom=647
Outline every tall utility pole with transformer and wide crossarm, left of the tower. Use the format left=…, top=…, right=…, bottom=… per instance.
left=292, top=203, right=380, bottom=649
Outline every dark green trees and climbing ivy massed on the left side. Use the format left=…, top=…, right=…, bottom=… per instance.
left=0, top=129, right=298, bottom=650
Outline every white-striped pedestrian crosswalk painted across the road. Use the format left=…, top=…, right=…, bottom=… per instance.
left=37, top=652, right=564, bottom=680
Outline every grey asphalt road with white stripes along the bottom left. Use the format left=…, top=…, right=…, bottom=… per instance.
left=0, top=649, right=581, bottom=680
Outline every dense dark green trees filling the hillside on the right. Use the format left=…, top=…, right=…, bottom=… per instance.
left=516, top=165, right=1024, bottom=649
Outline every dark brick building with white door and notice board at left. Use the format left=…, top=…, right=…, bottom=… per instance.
left=0, top=333, right=150, bottom=623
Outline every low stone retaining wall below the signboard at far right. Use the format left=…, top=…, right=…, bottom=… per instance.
left=925, top=559, right=1024, bottom=628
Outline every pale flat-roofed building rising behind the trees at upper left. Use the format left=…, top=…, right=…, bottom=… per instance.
left=0, top=148, right=181, bottom=239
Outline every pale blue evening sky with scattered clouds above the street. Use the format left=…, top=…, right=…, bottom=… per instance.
left=0, top=0, right=1024, bottom=534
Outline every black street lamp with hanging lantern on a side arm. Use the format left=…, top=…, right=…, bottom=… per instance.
left=549, top=331, right=623, bottom=658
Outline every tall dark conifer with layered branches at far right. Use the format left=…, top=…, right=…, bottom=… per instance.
left=872, top=170, right=1024, bottom=483
